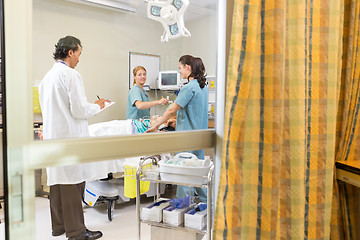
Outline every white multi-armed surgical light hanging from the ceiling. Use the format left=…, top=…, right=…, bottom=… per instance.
left=147, top=0, right=191, bottom=42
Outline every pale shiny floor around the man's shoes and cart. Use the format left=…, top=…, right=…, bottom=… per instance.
left=0, top=185, right=206, bottom=240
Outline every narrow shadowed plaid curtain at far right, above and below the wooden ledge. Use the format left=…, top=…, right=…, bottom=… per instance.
left=331, top=0, right=360, bottom=240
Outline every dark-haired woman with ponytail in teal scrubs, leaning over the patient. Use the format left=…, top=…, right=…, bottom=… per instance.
left=147, top=55, right=209, bottom=202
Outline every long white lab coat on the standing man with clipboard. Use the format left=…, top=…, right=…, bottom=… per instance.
left=39, top=62, right=102, bottom=185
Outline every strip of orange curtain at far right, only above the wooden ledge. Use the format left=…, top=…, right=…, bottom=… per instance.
left=336, top=0, right=360, bottom=161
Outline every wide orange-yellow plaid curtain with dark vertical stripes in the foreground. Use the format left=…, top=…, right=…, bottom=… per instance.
left=213, top=0, right=344, bottom=240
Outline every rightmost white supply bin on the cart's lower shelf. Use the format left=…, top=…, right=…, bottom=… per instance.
left=184, top=203, right=207, bottom=230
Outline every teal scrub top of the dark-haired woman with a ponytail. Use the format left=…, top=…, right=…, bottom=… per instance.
left=175, top=79, right=209, bottom=159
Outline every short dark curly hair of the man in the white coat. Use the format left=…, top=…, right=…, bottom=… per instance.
left=53, top=36, right=82, bottom=60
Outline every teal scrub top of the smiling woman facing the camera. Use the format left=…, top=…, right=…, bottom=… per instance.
left=126, top=84, right=150, bottom=119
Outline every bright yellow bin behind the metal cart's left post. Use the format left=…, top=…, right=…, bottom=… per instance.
left=124, top=162, right=152, bottom=198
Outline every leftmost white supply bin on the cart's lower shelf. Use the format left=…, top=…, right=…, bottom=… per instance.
left=141, top=198, right=170, bottom=223
